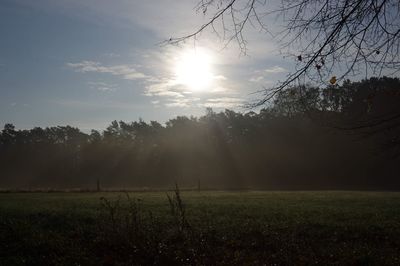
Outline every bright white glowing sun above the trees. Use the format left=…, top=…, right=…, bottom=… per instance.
left=174, top=48, right=213, bottom=91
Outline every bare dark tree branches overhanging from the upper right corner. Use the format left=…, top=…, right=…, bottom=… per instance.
left=165, top=0, right=400, bottom=106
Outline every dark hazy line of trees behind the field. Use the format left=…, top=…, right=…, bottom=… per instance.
left=0, top=77, right=400, bottom=189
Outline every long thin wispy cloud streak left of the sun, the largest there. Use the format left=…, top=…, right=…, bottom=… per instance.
left=67, top=61, right=148, bottom=80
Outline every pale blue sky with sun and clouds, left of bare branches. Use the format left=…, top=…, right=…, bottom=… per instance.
left=0, top=0, right=290, bottom=131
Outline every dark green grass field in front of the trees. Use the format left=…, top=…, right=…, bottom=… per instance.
left=0, top=191, right=400, bottom=265
